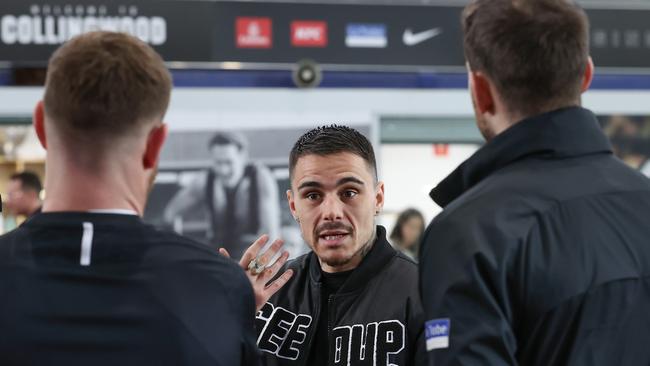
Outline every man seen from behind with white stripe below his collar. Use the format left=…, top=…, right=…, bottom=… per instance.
left=0, top=32, right=286, bottom=366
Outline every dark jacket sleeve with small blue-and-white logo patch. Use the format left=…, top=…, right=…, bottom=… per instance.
left=420, top=216, right=517, bottom=366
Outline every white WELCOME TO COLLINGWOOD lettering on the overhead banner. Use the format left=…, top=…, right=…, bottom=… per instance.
left=0, top=5, right=167, bottom=46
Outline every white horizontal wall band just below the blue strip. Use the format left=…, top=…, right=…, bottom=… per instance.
left=0, top=87, right=650, bottom=122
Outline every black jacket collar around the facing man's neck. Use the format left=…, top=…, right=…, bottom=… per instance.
left=309, top=226, right=397, bottom=293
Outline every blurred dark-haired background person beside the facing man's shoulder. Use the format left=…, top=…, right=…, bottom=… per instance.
left=390, top=208, right=424, bottom=262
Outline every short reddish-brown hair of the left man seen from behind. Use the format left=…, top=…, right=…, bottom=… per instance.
left=43, top=32, right=172, bottom=144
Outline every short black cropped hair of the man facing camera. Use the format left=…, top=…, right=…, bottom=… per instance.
left=289, top=124, right=377, bottom=180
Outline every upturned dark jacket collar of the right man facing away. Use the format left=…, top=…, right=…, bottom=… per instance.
left=430, top=107, right=612, bottom=208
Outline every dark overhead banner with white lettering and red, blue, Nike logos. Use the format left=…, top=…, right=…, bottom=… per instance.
left=0, top=0, right=650, bottom=73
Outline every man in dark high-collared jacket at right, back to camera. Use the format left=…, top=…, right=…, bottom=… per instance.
left=420, top=0, right=650, bottom=366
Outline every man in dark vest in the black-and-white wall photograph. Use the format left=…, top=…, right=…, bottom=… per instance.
left=164, top=132, right=280, bottom=260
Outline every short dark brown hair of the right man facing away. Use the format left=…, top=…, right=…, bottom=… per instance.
left=462, top=0, right=589, bottom=116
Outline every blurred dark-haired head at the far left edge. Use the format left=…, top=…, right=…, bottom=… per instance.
left=5, top=171, right=43, bottom=218
